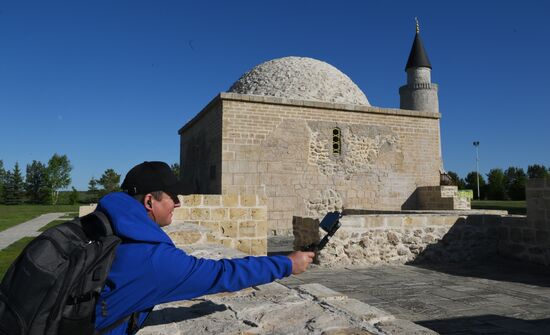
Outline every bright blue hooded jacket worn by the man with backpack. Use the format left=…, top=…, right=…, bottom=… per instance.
left=95, top=193, right=292, bottom=334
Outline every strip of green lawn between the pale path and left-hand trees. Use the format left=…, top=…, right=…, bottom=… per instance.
left=0, top=205, right=80, bottom=231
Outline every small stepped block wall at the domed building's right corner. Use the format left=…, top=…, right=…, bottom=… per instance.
left=416, top=186, right=471, bottom=210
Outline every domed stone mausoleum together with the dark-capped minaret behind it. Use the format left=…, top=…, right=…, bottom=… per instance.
left=179, top=31, right=469, bottom=235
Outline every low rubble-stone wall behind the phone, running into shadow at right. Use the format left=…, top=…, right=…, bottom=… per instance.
left=293, top=179, right=550, bottom=266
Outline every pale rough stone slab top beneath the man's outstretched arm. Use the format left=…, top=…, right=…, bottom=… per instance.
left=138, top=245, right=436, bottom=335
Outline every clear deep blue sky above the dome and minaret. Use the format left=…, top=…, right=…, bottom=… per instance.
left=0, top=0, right=550, bottom=190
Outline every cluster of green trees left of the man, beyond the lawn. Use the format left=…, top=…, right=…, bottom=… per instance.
left=0, top=154, right=76, bottom=205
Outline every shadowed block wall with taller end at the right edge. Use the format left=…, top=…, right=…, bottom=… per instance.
left=499, top=179, right=550, bottom=265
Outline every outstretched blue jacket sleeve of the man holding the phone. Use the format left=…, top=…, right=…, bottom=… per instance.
left=147, top=244, right=292, bottom=304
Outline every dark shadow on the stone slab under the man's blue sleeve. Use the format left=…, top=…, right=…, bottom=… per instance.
left=145, top=301, right=227, bottom=326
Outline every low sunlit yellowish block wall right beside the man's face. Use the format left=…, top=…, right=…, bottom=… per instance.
left=171, top=194, right=267, bottom=255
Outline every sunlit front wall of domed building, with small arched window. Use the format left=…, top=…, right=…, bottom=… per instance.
left=207, top=93, right=441, bottom=235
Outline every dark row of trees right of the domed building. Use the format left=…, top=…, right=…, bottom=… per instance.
left=448, top=164, right=550, bottom=200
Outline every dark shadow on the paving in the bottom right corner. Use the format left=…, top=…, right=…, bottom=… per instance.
left=415, top=314, right=550, bottom=335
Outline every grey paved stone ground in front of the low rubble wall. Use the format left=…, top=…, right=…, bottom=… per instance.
left=280, top=259, right=550, bottom=335
